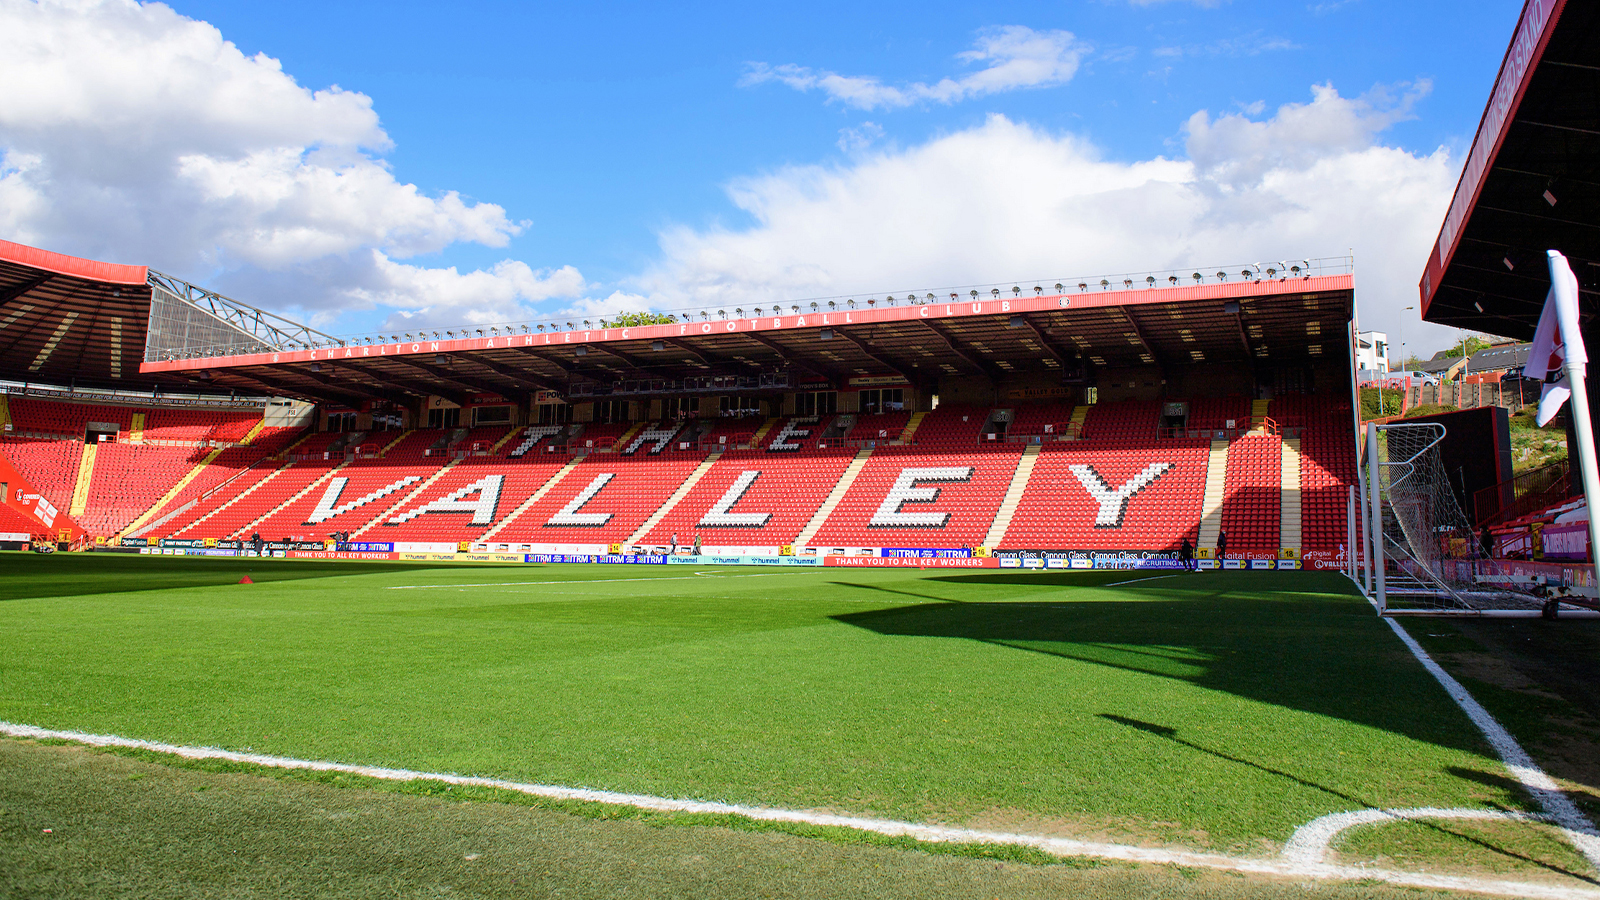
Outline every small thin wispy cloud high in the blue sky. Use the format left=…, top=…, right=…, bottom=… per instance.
left=741, top=26, right=1088, bottom=109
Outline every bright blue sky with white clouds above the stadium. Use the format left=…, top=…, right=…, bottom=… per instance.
left=0, top=0, right=1520, bottom=349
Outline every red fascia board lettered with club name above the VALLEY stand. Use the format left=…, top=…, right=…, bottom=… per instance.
left=139, top=274, right=1355, bottom=373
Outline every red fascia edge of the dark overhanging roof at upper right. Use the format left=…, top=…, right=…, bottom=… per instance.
left=1418, top=0, right=1566, bottom=319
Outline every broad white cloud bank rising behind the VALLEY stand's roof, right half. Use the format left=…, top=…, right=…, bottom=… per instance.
left=637, top=85, right=1456, bottom=341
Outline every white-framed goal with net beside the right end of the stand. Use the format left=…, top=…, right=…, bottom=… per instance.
left=1365, top=423, right=1539, bottom=612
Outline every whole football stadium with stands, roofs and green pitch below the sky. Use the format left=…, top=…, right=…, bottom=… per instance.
left=9, top=0, right=1600, bottom=898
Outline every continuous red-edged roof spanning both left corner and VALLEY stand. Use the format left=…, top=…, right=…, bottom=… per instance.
left=0, top=242, right=1354, bottom=407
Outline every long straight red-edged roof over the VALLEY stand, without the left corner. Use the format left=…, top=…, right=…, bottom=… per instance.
left=141, top=261, right=1354, bottom=405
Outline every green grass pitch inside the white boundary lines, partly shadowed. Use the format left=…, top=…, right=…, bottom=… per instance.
left=0, top=554, right=1586, bottom=873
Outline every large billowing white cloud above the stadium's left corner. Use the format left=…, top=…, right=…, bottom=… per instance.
left=0, top=0, right=556, bottom=319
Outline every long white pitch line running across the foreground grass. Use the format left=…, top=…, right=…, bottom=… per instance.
left=9, top=722, right=1600, bottom=900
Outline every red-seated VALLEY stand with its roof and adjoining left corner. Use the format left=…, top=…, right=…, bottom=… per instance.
left=0, top=235, right=1355, bottom=569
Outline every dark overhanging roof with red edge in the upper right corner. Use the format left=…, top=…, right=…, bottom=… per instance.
left=1419, top=0, right=1600, bottom=340
